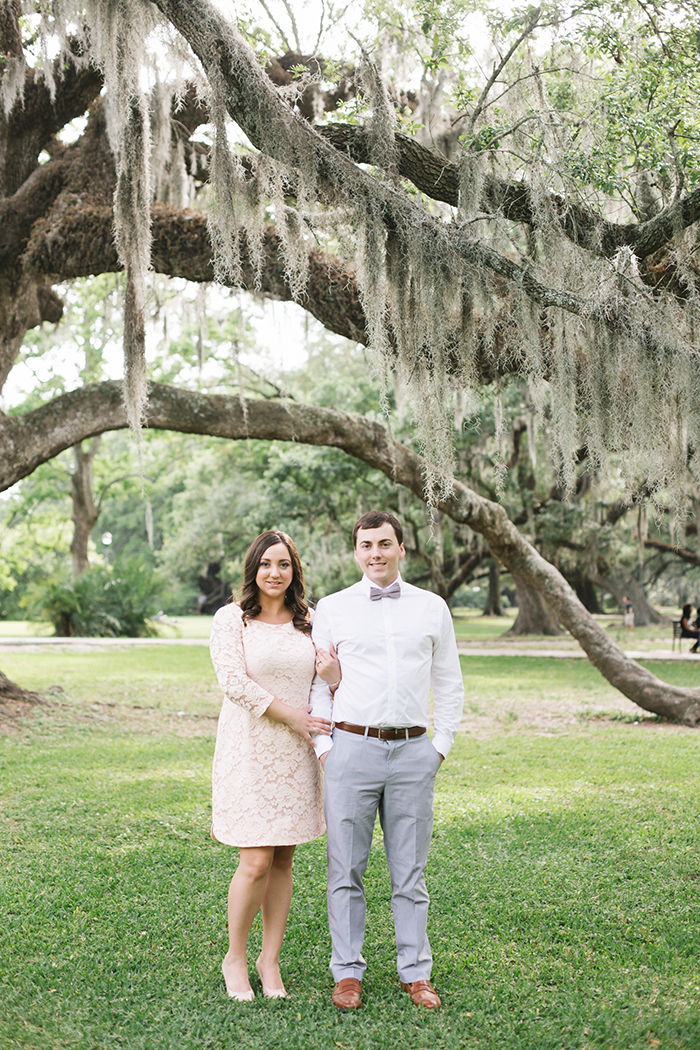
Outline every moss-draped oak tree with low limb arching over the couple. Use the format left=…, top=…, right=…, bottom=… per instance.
left=0, top=0, right=700, bottom=721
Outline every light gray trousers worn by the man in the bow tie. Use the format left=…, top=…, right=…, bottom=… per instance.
left=323, top=729, right=440, bottom=983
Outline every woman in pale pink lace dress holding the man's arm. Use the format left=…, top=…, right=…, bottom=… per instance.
left=211, top=531, right=340, bottom=1002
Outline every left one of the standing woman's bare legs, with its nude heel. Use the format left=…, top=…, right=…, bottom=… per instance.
left=224, top=846, right=277, bottom=993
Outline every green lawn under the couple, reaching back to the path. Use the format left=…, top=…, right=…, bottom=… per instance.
left=0, top=647, right=700, bottom=1050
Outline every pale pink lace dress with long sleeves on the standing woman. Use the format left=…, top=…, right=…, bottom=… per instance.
left=210, top=605, right=325, bottom=846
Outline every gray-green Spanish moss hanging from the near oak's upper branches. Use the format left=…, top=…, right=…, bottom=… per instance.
left=19, top=0, right=700, bottom=525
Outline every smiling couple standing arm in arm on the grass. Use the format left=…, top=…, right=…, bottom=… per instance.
left=211, top=511, right=464, bottom=1010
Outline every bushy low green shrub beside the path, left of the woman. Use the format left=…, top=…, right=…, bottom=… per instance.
left=27, top=561, right=163, bottom=638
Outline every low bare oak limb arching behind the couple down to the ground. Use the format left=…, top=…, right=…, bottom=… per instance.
left=0, top=382, right=700, bottom=726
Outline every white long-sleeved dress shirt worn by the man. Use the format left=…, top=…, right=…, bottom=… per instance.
left=311, top=576, right=464, bottom=757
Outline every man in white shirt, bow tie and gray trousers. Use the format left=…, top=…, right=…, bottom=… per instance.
left=312, top=510, right=464, bottom=1010
